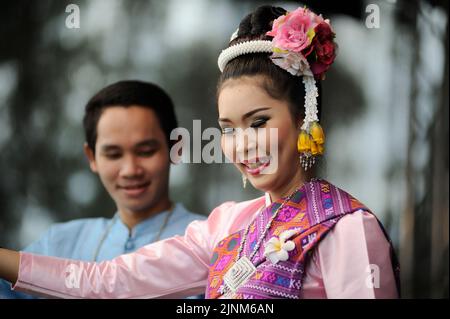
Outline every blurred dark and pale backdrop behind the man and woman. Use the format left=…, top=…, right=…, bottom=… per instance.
left=0, top=0, right=449, bottom=298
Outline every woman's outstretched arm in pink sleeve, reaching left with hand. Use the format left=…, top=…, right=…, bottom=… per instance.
left=0, top=203, right=250, bottom=298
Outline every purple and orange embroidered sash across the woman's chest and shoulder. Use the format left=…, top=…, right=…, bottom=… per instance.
left=206, top=180, right=399, bottom=299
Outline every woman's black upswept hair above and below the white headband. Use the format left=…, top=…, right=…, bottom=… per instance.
left=217, top=6, right=321, bottom=123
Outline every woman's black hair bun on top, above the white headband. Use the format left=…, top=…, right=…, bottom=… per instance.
left=238, top=5, right=286, bottom=38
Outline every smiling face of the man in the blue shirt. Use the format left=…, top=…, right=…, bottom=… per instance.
left=85, top=106, right=170, bottom=214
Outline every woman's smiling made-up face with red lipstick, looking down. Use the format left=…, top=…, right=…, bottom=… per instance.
left=218, top=76, right=302, bottom=197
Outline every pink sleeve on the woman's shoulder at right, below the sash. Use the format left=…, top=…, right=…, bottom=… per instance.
left=302, top=212, right=398, bottom=299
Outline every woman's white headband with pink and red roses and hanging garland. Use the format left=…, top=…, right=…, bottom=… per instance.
left=218, top=7, right=337, bottom=170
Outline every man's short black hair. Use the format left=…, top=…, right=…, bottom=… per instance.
left=83, top=81, right=178, bottom=153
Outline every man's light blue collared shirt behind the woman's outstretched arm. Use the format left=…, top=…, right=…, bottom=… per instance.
left=0, top=204, right=206, bottom=299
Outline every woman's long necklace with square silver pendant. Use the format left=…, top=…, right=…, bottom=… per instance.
left=223, top=189, right=298, bottom=296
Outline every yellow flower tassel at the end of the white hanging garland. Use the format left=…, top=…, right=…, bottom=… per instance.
left=297, top=121, right=325, bottom=171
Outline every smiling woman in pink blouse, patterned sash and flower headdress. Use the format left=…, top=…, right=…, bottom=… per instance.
left=0, top=6, right=398, bottom=298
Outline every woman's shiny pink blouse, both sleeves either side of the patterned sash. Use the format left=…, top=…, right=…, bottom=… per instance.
left=14, top=197, right=396, bottom=298
